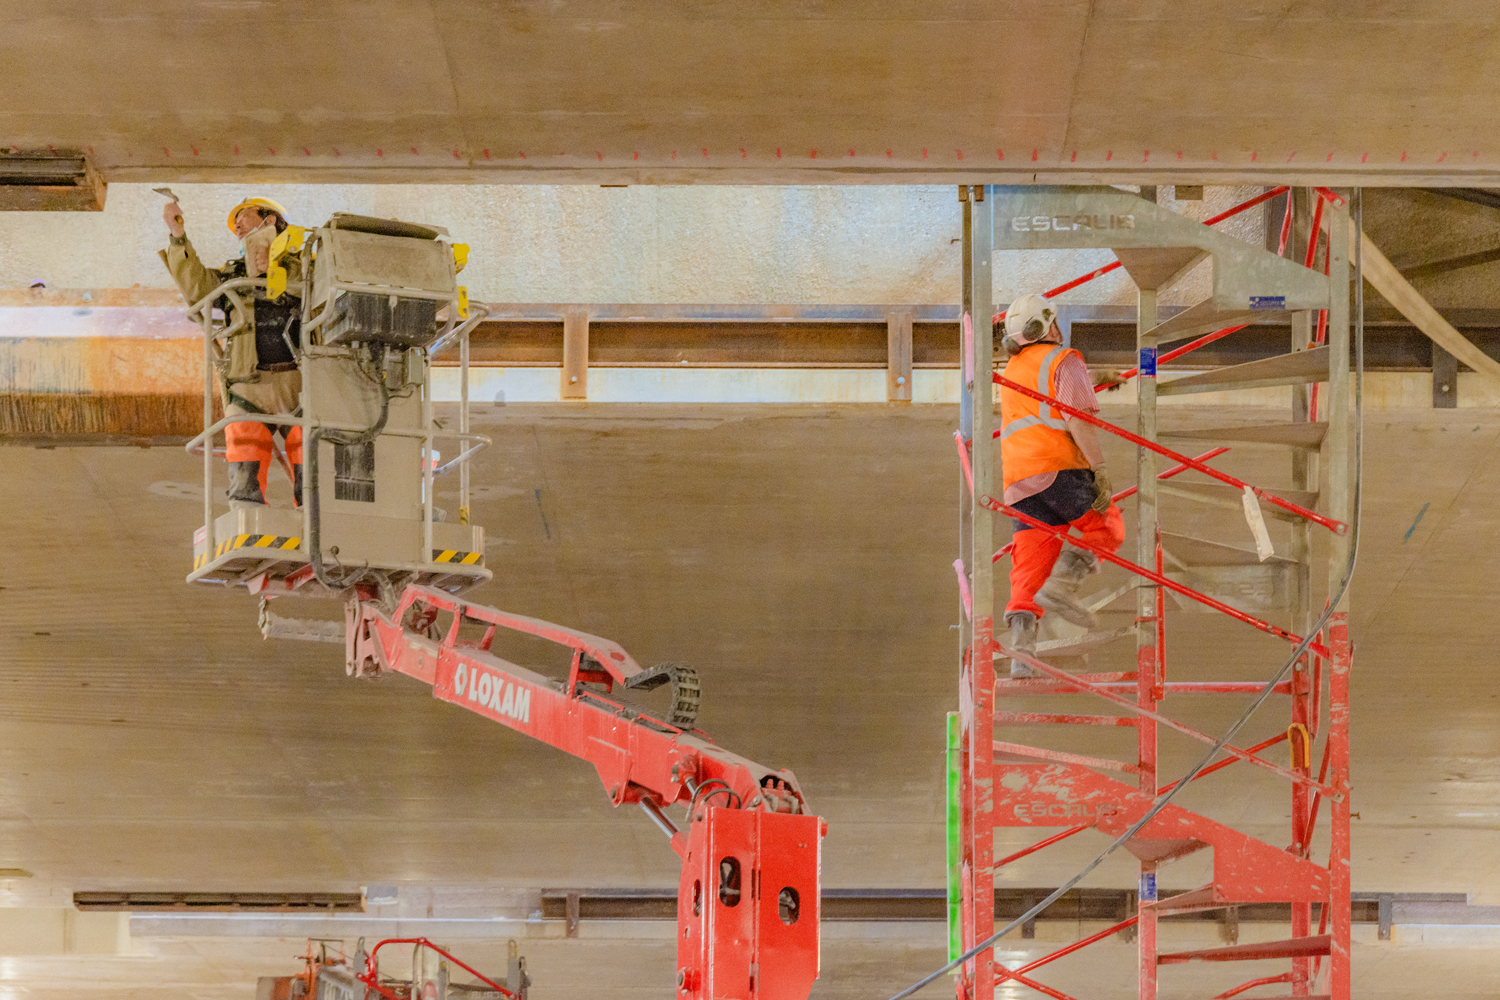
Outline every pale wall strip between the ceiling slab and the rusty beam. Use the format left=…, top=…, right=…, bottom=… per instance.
left=0, top=184, right=1262, bottom=304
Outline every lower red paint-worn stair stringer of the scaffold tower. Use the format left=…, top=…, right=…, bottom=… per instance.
left=995, top=760, right=1328, bottom=904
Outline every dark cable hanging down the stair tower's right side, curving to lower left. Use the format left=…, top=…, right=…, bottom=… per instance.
left=891, top=187, right=1365, bottom=1000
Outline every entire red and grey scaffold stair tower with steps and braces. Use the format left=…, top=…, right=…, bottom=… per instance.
left=950, top=187, right=1352, bottom=1000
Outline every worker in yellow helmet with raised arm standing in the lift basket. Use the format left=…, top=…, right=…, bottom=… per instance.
left=161, top=198, right=302, bottom=507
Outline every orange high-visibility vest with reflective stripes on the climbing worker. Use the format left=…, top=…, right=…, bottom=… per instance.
left=1001, top=343, right=1089, bottom=487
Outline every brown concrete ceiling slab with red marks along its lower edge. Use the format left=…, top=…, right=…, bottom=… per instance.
left=0, top=0, right=1500, bottom=186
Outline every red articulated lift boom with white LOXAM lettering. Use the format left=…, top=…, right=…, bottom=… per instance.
left=345, top=586, right=825, bottom=1000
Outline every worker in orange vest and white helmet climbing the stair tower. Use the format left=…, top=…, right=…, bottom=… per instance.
left=1001, top=295, right=1125, bottom=678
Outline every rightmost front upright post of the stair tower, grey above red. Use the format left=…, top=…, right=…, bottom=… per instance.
left=1323, top=194, right=1353, bottom=1000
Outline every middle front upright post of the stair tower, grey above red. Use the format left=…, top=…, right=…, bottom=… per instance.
left=1136, top=277, right=1161, bottom=1000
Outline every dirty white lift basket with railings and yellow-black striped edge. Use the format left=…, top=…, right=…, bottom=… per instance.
left=186, top=213, right=492, bottom=597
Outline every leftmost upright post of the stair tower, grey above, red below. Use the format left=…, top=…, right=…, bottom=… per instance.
left=960, top=187, right=996, bottom=1000
